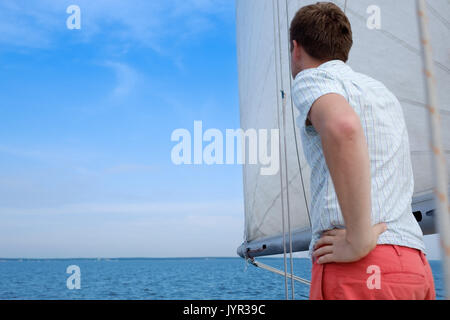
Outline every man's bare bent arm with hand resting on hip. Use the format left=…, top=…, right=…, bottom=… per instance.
left=309, top=94, right=386, bottom=263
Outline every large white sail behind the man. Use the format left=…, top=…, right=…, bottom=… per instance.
left=237, top=0, right=450, bottom=256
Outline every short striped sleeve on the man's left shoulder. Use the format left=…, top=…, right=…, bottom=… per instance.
left=292, top=69, right=347, bottom=128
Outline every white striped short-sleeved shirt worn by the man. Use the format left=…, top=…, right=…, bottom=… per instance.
left=293, top=60, right=425, bottom=254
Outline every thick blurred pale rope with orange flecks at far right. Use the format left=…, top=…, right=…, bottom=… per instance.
left=417, top=0, right=450, bottom=300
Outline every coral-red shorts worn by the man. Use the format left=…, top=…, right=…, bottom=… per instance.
left=310, top=245, right=436, bottom=300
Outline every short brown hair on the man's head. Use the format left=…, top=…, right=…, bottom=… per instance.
left=290, top=2, right=353, bottom=62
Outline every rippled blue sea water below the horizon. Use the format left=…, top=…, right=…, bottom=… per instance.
left=0, top=258, right=443, bottom=300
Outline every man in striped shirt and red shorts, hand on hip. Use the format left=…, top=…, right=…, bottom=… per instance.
left=290, top=2, right=436, bottom=300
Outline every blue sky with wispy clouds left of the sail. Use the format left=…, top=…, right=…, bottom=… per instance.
left=0, top=0, right=244, bottom=258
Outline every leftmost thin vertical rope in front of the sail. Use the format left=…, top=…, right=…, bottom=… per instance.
left=272, top=0, right=289, bottom=300
